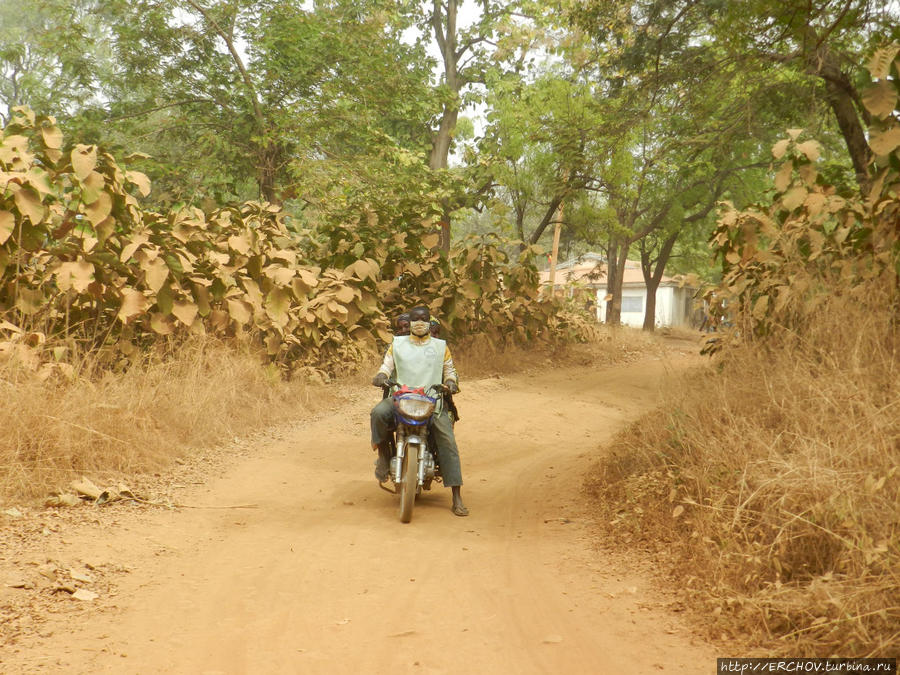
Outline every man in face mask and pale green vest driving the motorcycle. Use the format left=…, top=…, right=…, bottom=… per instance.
left=371, top=307, right=469, bottom=516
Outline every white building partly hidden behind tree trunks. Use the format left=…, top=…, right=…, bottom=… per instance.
left=541, top=253, right=697, bottom=328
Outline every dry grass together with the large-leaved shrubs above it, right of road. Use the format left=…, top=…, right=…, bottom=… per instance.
left=589, top=55, right=900, bottom=656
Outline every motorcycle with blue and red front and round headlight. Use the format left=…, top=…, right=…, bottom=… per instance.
left=379, top=380, right=447, bottom=523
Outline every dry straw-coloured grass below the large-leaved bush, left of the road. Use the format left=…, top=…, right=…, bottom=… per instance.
left=0, top=339, right=338, bottom=501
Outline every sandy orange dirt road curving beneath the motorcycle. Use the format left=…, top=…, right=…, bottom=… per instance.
left=3, top=346, right=715, bottom=675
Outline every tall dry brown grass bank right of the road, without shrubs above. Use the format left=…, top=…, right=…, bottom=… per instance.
left=589, top=288, right=900, bottom=656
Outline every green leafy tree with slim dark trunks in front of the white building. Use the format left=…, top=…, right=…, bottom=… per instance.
left=572, top=1, right=860, bottom=329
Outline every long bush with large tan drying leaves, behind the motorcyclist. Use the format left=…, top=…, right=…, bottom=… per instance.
left=0, top=108, right=591, bottom=378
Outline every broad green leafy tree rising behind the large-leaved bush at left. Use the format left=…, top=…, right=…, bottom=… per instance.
left=59, top=0, right=431, bottom=211
